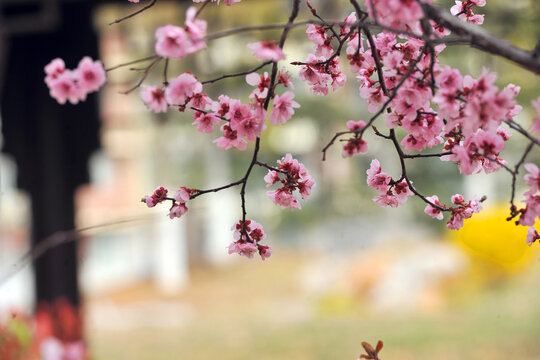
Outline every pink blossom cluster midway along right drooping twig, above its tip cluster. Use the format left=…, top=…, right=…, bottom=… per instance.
left=366, top=159, right=413, bottom=207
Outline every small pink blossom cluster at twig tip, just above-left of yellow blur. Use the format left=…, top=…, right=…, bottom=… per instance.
left=424, top=194, right=482, bottom=230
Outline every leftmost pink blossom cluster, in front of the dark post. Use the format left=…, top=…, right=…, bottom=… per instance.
left=45, top=56, right=106, bottom=104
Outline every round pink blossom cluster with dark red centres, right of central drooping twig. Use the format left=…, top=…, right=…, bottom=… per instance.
left=264, top=154, right=315, bottom=210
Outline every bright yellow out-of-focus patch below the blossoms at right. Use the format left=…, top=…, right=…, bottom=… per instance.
left=448, top=205, right=535, bottom=270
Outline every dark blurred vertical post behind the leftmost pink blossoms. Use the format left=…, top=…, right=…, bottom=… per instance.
left=0, top=1, right=99, bottom=306
